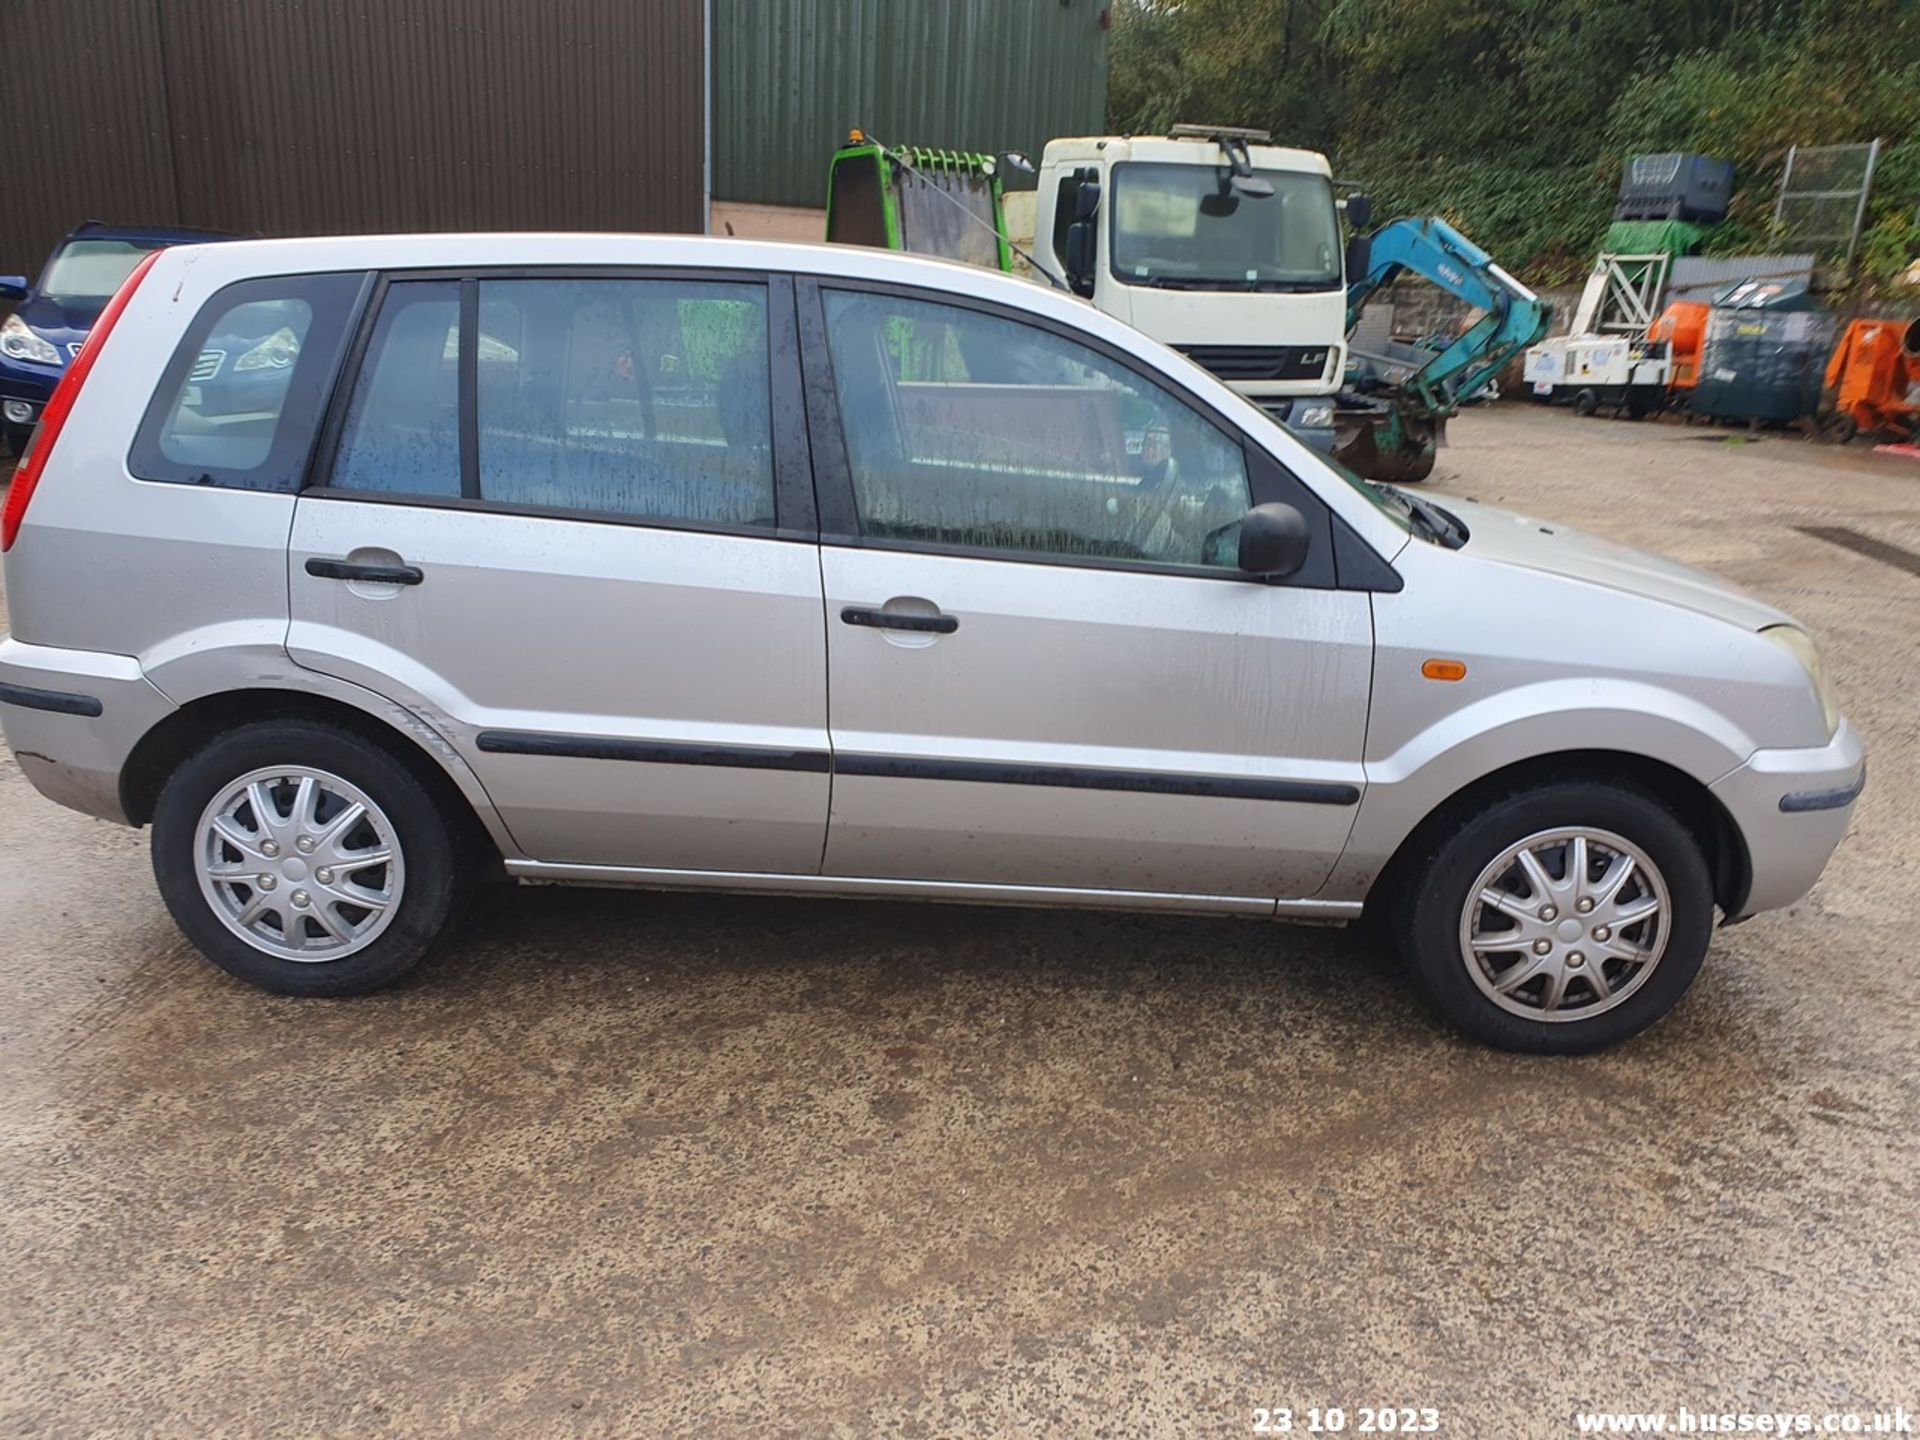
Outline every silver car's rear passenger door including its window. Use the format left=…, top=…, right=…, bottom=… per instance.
left=288, top=273, right=829, bottom=874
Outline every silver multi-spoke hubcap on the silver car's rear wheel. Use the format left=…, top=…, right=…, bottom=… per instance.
left=194, top=766, right=407, bottom=960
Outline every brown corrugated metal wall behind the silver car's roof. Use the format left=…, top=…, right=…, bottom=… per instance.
left=0, top=0, right=707, bottom=271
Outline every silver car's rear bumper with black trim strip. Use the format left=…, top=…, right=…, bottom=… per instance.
left=0, top=637, right=175, bottom=824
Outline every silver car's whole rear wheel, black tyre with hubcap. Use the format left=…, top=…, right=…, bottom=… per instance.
left=154, top=720, right=474, bottom=995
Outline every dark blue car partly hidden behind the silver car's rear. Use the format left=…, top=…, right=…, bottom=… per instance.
left=0, top=221, right=232, bottom=455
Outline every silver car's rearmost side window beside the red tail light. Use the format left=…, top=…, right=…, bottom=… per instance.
left=127, top=273, right=365, bottom=492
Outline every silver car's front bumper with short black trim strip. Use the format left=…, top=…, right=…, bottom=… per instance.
left=1713, top=720, right=1866, bottom=920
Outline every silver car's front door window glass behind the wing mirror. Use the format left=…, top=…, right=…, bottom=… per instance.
left=826, top=290, right=1250, bottom=568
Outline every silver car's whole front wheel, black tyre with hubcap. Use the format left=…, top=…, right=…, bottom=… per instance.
left=1392, top=781, right=1713, bottom=1054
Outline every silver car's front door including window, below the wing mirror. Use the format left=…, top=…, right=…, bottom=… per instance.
left=801, top=280, right=1373, bottom=908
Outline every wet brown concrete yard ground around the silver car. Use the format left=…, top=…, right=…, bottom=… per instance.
left=0, top=403, right=1920, bottom=1440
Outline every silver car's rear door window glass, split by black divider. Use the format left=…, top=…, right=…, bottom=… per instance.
left=332, top=278, right=774, bottom=526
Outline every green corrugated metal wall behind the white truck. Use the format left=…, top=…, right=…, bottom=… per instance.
left=712, top=0, right=1108, bottom=205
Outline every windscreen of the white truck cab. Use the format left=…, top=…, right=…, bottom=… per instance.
left=1110, top=161, right=1340, bottom=290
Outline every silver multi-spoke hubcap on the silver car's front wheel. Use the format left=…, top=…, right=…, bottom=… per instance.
left=1459, top=829, right=1670, bottom=1021
